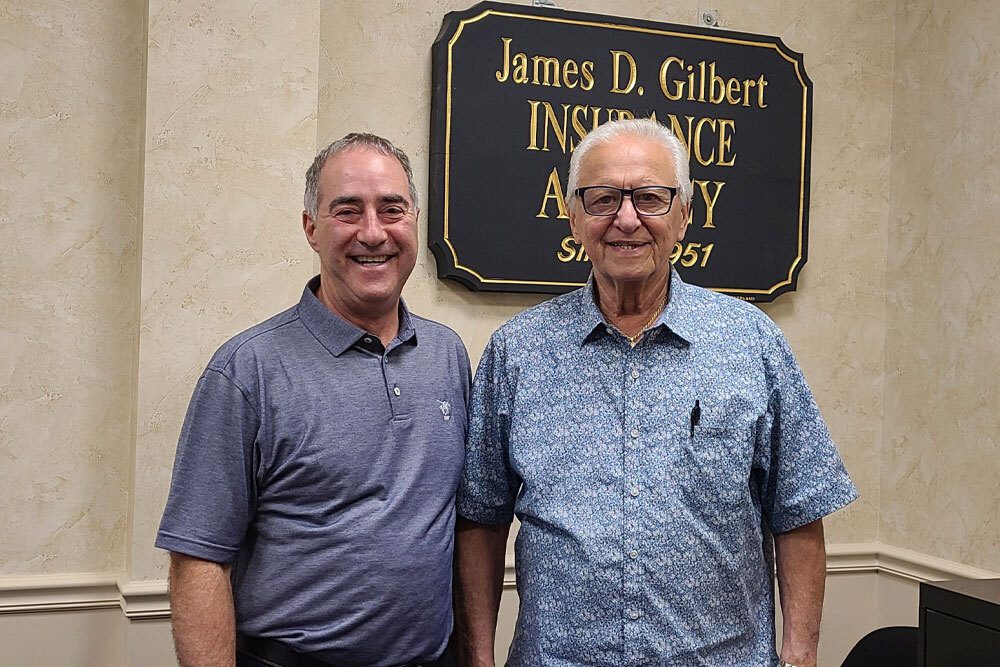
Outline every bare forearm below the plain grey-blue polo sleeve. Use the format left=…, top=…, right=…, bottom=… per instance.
left=170, top=552, right=236, bottom=667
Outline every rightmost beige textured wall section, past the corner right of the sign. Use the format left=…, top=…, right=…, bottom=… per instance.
left=884, top=0, right=1000, bottom=571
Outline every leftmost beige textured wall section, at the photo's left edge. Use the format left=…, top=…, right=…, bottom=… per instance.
left=0, top=0, right=142, bottom=575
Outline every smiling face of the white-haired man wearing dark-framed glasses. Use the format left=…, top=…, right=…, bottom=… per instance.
left=569, top=135, right=688, bottom=300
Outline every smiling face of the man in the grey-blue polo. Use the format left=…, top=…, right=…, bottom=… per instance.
left=302, top=147, right=418, bottom=327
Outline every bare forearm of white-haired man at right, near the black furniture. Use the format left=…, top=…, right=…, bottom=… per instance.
left=774, top=519, right=826, bottom=667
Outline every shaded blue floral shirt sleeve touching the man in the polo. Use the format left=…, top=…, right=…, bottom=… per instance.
left=456, top=334, right=520, bottom=524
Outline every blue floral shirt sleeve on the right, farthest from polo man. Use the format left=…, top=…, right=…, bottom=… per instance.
left=754, top=328, right=858, bottom=533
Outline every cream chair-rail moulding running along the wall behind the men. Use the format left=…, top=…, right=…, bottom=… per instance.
left=0, top=542, right=1000, bottom=620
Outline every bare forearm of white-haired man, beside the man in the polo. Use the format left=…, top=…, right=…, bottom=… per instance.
left=455, top=517, right=510, bottom=667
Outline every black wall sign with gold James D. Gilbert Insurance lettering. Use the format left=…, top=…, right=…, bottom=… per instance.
left=428, top=2, right=812, bottom=301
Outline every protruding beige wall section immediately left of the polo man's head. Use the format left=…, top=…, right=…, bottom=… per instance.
left=129, top=0, right=319, bottom=579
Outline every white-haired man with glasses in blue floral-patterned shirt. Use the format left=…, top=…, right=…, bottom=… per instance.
left=456, top=120, right=858, bottom=667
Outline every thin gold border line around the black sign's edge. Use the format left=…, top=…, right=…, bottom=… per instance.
left=444, top=9, right=809, bottom=294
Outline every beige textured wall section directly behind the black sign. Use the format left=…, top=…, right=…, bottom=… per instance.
left=319, top=0, right=893, bottom=542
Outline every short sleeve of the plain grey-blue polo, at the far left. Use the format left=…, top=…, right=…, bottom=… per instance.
left=156, top=368, right=260, bottom=563
